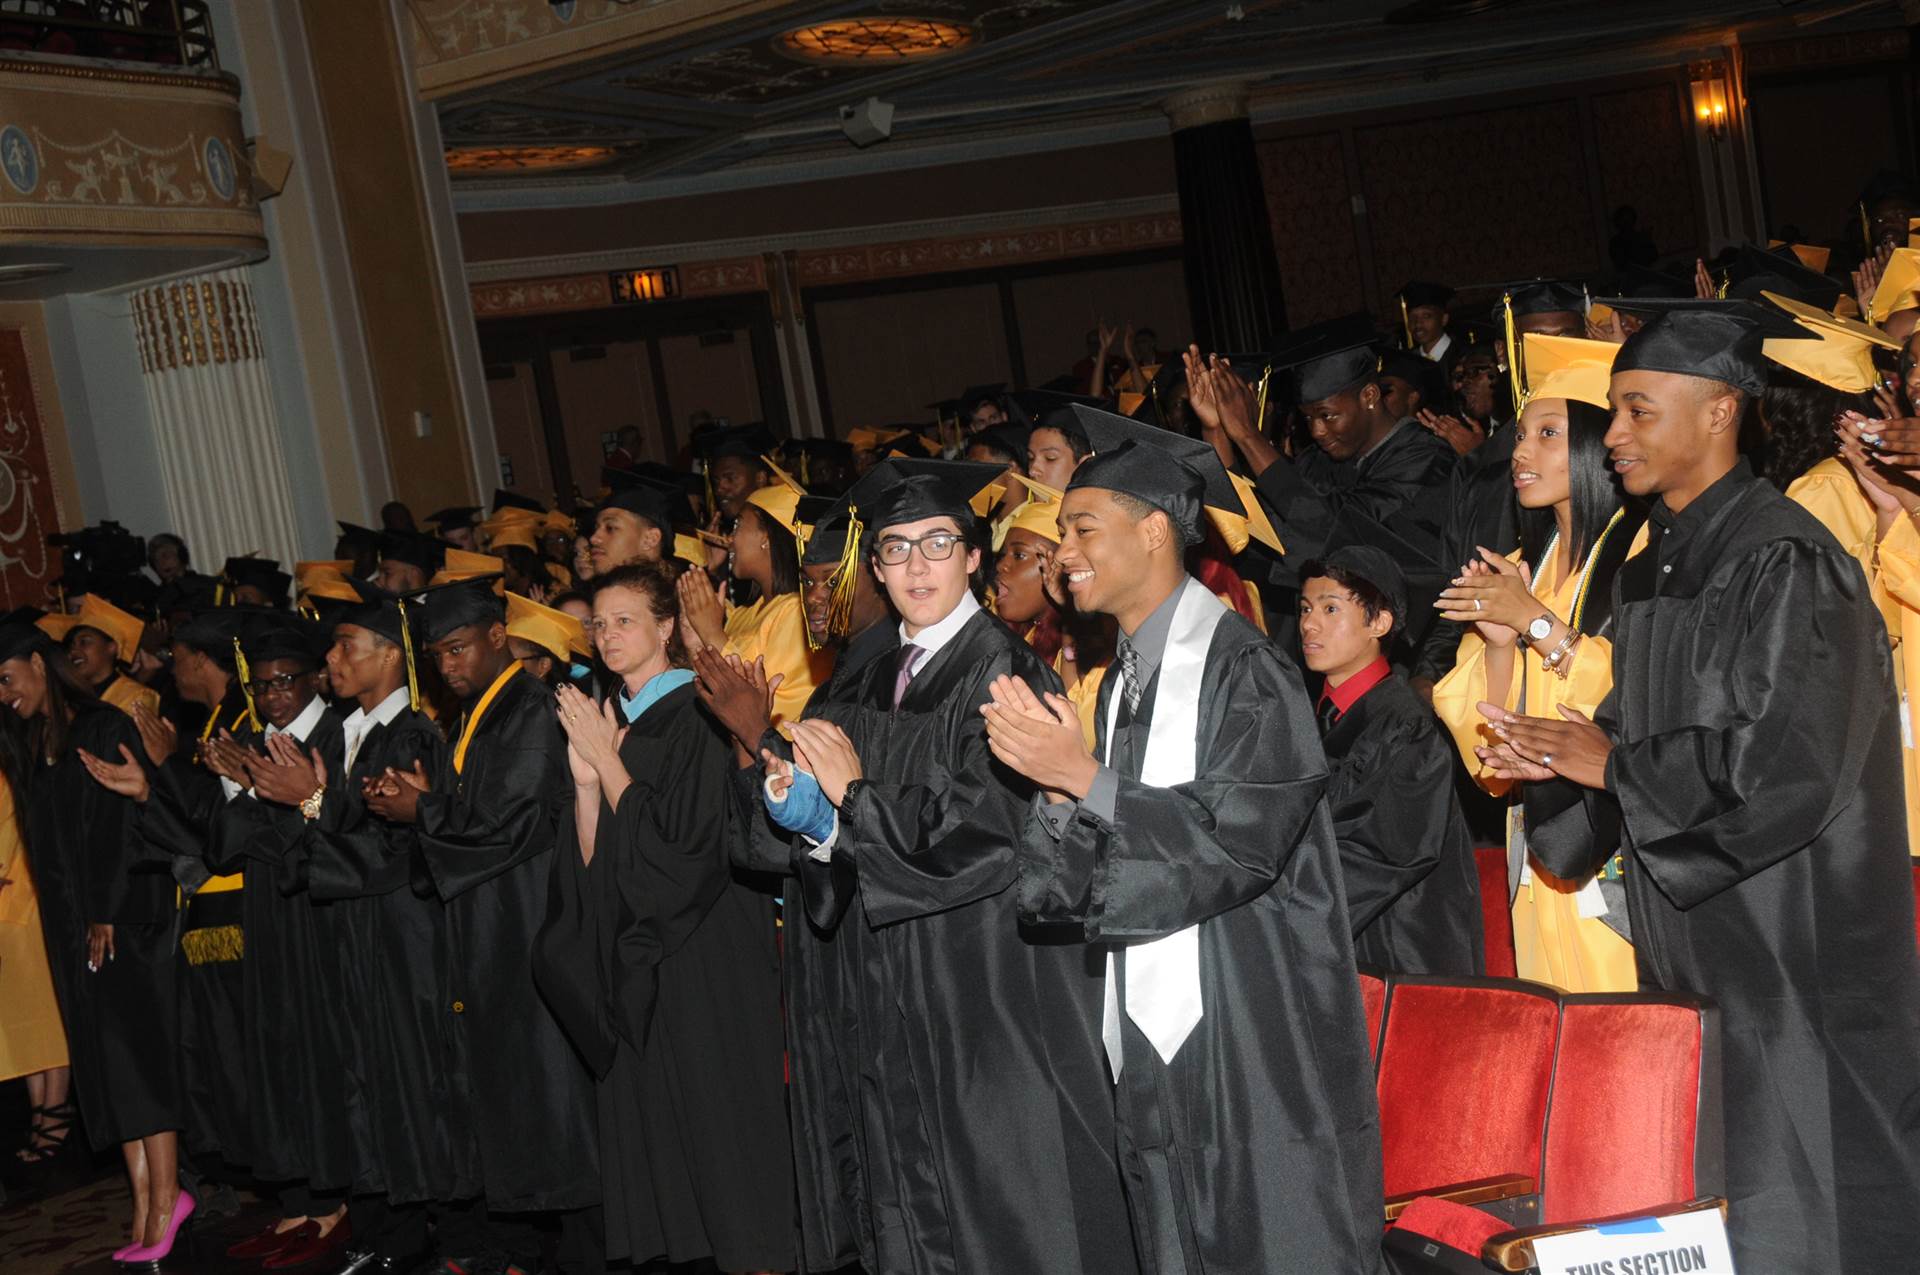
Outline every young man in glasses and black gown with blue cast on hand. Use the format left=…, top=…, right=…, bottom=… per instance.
left=756, top=461, right=1135, bottom=1275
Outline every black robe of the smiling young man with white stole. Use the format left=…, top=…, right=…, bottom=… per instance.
left=1021, top=614, right=1382, bottom=1275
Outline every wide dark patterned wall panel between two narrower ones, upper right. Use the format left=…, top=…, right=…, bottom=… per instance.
left=1354, top=98, right=1601, bottom=315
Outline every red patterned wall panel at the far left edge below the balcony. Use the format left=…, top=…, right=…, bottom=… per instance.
left=0, top=326, right=60, bottom=609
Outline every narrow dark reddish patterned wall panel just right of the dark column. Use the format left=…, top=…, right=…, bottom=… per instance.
left=1258, top=132, right=1361, bottom=326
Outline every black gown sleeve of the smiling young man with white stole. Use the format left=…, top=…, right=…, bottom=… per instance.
left=1021, top=643, right=1327, bottom=939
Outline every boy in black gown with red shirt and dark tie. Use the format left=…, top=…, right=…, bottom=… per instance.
left=1300, top=545, right=1486, bottom=974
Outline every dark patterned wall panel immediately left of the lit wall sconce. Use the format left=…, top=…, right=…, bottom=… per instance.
left=1590, top=84, right=1701, bottom=255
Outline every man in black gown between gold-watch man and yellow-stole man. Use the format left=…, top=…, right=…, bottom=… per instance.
left=299, top=582, right=459, bottom=1275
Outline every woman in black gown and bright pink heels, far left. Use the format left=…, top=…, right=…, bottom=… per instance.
left=0, top=624, right=194, bottom=1260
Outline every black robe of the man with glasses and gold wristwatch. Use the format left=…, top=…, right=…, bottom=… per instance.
left=205, top=712, right=353, bottom=1191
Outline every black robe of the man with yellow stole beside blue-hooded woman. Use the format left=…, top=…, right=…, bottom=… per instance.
left=415, top=672, right=601, bottom=1212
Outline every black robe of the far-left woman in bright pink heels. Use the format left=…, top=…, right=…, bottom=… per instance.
left=21, top=705, right=188, bottom=1150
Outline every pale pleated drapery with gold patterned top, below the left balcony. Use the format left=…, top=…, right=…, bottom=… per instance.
left=131, top=269, right=300, bottom=570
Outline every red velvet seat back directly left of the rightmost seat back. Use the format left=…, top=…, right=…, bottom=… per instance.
left=1379, top=975, right=1559, bottom=1215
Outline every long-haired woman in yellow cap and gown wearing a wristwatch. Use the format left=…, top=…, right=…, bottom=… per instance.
left=1434, top=332, right=1645, bottom=991
